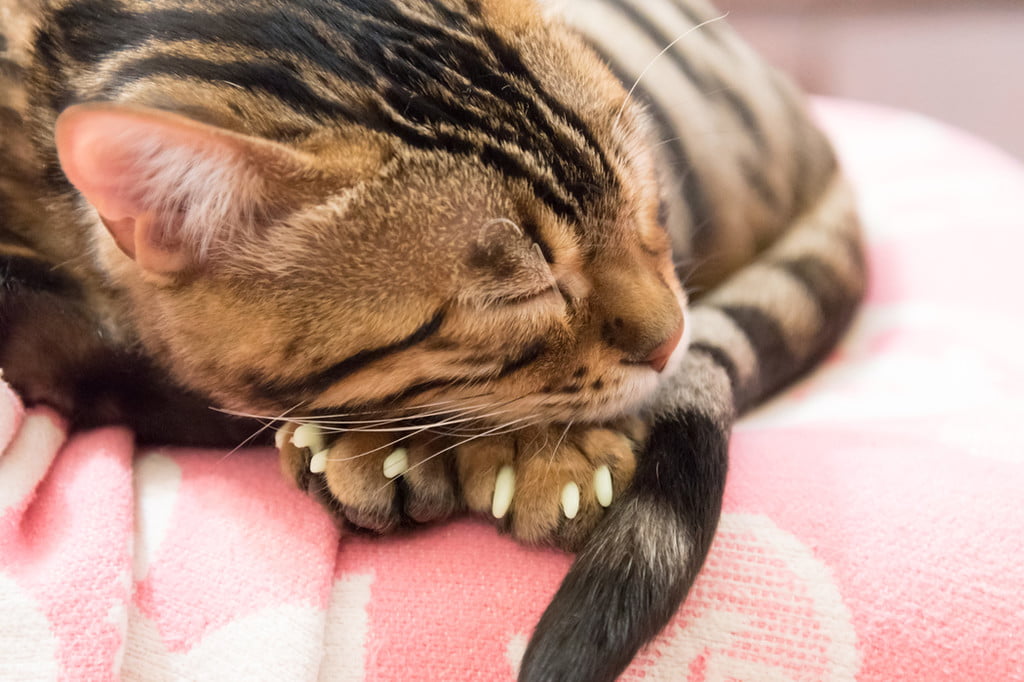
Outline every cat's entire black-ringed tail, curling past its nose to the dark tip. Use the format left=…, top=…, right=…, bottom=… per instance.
left=519, top=176, right=866, bottom=682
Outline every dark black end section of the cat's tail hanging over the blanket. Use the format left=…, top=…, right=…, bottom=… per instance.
left=519, top=401, right=728, bottom=682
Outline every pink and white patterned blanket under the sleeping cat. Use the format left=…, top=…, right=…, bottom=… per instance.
left=0, top=102, right=1024, bottom=682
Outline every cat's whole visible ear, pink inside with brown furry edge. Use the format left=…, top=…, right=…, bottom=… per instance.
left=55, top=103, right=317, bottom=274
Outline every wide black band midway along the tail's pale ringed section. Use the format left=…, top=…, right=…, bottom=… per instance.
left=719, top=305, right=794, bottom=412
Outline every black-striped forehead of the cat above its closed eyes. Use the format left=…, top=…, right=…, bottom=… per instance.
left=290, top=0, right=623, bottom=220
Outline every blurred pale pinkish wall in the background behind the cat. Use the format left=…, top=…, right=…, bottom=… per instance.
left=717, top=0, right=1024, bottom=159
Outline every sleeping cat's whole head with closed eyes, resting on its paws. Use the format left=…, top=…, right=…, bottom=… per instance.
left=49, top=2, right=685, bottom=421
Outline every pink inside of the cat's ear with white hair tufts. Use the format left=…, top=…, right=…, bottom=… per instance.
left=55, top=104, right=238, bottom=273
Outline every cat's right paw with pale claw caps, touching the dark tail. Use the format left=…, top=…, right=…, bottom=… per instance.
left=456, top=419, right=645, bottom=551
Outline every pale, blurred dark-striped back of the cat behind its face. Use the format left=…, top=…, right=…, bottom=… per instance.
left=542, top=0, right=836, bottom=289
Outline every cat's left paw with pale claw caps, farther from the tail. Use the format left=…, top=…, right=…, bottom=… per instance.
left=276, top=424, right=462, bottom=534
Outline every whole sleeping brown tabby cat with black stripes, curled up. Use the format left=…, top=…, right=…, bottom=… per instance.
left=0, top=0, right=865, bottom=681
